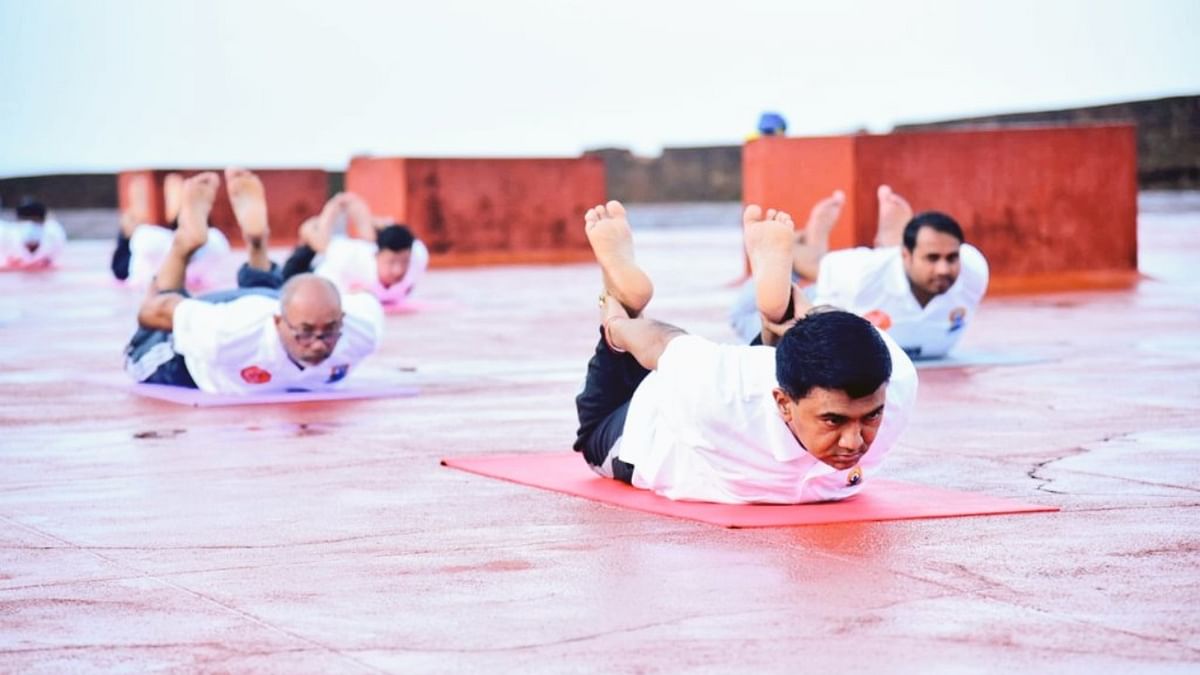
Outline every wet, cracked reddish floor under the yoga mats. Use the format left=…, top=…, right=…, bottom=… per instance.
left=0, top=197, right=1200, bottom=673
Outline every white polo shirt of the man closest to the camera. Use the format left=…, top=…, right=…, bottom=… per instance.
left=618, top=333, right=917, bottom=503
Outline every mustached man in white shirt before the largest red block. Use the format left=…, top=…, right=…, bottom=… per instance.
left=731, top=185, right=988, bottom=358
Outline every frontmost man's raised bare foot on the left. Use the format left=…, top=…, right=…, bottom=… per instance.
left=583, top=199, right=654, bottom=317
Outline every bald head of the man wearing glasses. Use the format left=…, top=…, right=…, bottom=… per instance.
left=275, top=274, right=343, bottom=365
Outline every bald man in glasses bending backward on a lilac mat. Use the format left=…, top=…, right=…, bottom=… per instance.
left=125, top=168, right=383, bottom=394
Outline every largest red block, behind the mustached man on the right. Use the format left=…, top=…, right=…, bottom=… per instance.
left=743, top=125, right=1138, bottom=291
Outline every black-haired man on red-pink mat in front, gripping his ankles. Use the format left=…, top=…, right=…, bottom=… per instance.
left=575, top=196, right=917, bottom=503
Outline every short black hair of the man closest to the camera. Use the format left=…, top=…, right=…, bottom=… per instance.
left=775, top=310, right=892, bottom=400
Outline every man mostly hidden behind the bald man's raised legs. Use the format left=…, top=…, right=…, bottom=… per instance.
left=110, top=173, right=229, bottom=288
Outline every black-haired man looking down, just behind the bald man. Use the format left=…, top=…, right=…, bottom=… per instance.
left=283, top=192, right=430, bottom=304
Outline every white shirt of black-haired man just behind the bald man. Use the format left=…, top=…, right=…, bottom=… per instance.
left=314, top=237, right=430, bottom=305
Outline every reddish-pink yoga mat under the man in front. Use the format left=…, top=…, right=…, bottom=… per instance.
left=442, top=453, right=1058, bottom=527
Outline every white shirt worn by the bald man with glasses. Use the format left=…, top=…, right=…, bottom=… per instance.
left=172, top=293, right=383, bottom=394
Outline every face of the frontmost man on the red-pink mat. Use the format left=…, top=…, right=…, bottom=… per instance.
left=774, top=382, right=888, bottom=471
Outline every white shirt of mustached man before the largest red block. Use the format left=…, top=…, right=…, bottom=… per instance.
left=814, top=244, right=988, bottom=358
